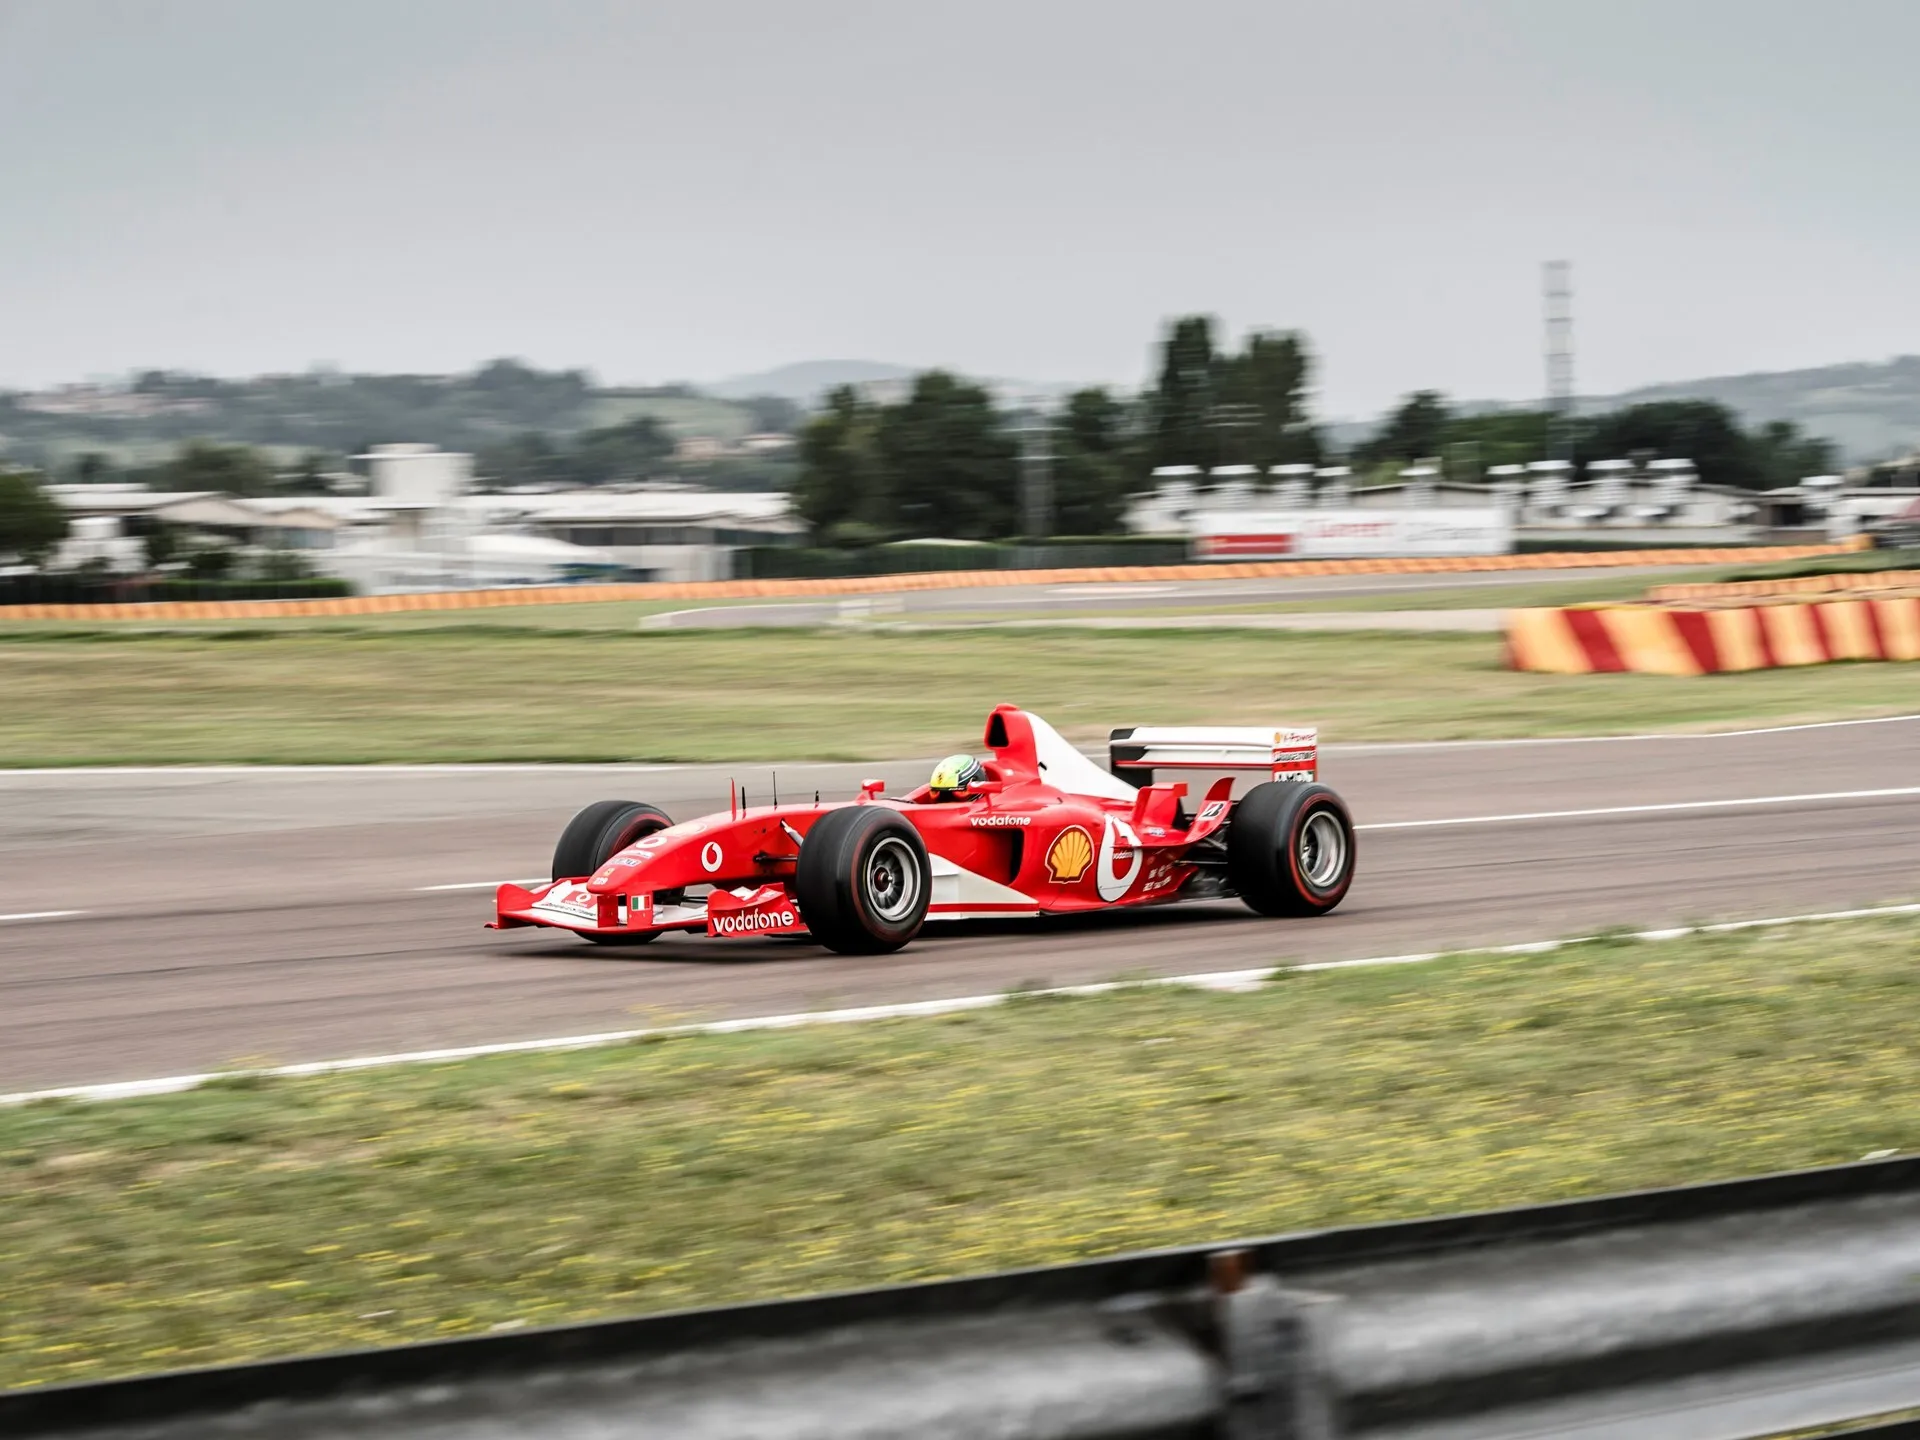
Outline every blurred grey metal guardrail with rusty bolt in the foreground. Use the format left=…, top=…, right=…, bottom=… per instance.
left=11, top=1158, right=1920, bottom=1440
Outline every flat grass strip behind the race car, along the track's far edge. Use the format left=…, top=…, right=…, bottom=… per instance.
left=0, top=624, right=1916, bottom=766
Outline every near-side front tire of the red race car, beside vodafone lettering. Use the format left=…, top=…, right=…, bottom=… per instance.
left=793, top=804, right=933, bottom=954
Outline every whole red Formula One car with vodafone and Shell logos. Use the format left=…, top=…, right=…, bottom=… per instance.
left=492, top=705, right=1354, bottom=954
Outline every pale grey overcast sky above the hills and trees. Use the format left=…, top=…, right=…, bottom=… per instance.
left=0, top=0, right=1920, bottom=417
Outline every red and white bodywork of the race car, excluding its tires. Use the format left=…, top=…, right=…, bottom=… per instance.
left=493, top=705, right=1313, bottom=937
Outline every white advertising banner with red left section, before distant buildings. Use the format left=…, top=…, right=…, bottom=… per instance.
left=1192, top=505, right=1513, bottom=561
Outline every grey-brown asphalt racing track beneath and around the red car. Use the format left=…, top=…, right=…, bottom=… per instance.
left=0, top=720, right=1920, bottom=1092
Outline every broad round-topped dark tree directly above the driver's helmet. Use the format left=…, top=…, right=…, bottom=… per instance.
left=877, top=371, right=1020, bottom=540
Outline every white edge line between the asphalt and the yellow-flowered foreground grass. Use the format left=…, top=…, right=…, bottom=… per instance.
left=0, top=904, right=1920, bottom=1106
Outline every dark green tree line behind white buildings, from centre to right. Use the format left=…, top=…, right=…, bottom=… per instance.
left=795, top=315, right=1836, bottom=545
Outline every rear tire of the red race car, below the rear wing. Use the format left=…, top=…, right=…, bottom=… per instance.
left=1227, top=781, right=1356, bottom=916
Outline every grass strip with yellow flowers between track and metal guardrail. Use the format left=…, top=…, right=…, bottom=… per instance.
left=0, top=920, right=1920, bottom=1386
